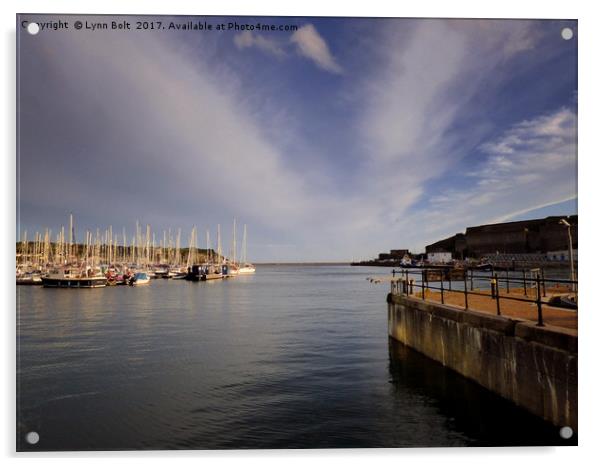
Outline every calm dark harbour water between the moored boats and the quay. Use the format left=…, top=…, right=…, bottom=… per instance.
left=17, top=266, right=563, bottom=450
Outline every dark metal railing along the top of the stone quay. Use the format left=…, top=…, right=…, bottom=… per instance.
left=391, top=268, right=578, bottom=327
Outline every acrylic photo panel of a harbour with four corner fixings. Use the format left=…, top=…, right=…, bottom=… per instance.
left=16, top=14, right=578, bottom=451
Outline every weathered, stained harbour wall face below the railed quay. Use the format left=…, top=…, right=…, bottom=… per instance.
left=387, top=294, right=578, bottom=431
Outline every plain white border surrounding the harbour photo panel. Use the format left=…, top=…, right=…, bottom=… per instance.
left=0, top=0, right=602, bottom=466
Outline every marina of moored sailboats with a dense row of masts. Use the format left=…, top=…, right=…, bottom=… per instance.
left=16, top=215, right=256, bottom=288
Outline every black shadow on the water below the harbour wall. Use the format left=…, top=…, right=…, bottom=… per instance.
left=389, top=338, right=578, bottom=447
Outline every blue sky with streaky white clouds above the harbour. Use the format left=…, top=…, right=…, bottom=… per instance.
left=17, top=15, right=578, bottom=262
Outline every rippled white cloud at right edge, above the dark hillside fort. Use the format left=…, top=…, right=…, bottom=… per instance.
left=404, top=108, right=577, bottom=248
